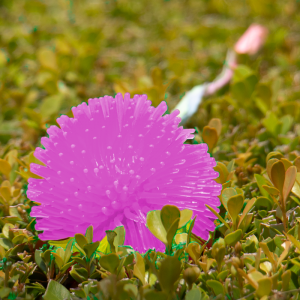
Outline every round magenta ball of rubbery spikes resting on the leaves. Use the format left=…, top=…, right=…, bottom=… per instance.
left=27, top=94, right=221, bottom=252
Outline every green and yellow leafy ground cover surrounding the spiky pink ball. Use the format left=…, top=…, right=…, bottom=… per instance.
left=0, top=0, right=300, bottom=300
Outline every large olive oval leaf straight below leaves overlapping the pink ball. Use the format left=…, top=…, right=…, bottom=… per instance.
left=158, top=256, right=181, bottom=293
